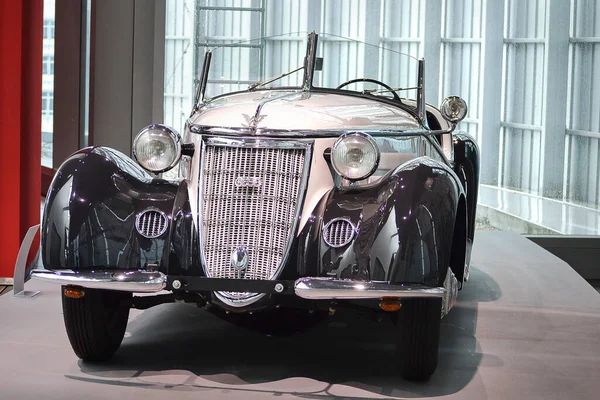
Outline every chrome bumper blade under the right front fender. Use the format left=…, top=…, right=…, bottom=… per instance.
left=294, top=278, right=446, bottom=300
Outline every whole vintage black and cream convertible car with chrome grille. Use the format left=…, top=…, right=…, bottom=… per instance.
left=31, top=32, right=479, bottom=380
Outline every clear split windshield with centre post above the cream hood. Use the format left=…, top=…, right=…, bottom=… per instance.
left=199, top=32, right=419, bottom=104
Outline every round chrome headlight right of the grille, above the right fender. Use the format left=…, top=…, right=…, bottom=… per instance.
left=331, top=132, right=379, bottom=181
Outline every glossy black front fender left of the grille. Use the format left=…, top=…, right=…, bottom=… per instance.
left=41, top=147, right=194, bottom=273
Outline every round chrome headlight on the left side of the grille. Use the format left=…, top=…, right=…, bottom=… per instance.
left=133, top=124, right=181, bottom=172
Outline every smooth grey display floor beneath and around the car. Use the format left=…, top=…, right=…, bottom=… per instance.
left=0, top=232, right=600, bottom=400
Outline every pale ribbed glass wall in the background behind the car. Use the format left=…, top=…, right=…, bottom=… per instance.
left=165, top=0, right=600, bottom=235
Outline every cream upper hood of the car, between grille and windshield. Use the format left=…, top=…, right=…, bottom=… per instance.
left=190, top=90, right=421, bottom=131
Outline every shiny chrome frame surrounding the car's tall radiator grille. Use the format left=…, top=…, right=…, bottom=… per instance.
left=198, top=136, right=314, bottom=307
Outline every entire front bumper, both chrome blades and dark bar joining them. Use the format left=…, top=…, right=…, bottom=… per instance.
left=31, top=270, right=446, bottom=300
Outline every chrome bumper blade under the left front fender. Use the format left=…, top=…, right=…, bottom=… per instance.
left=31, top=270, right=167, bottom=293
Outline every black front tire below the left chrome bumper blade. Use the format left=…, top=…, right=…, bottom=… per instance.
left=61, top=286, right=131, bottom=361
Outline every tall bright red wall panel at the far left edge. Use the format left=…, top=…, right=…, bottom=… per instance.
left=0, top=0, right=43, bottom=278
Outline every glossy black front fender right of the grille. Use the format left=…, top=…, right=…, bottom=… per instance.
left=319, top=157, right=464, bottom=286
